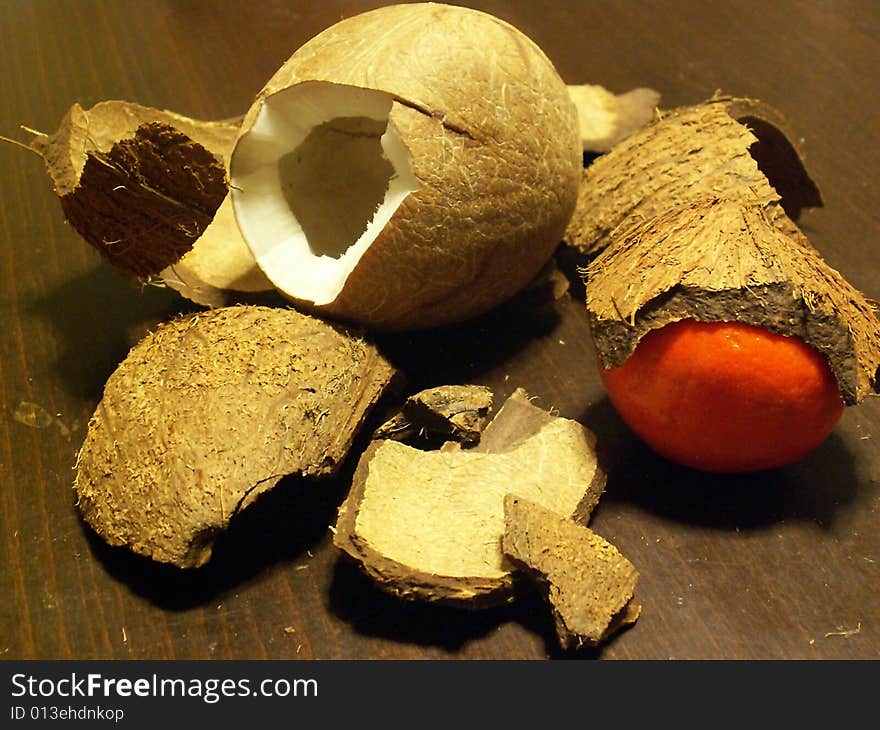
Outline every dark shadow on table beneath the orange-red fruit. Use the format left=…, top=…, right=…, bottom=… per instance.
left=580, top=398, right=859, bottom=530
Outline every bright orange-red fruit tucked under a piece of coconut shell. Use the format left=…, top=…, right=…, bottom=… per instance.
left=600, top=319, right=844, bottom=472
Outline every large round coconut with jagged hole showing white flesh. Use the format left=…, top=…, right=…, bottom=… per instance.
left=230, top=3, right=582, bottom=330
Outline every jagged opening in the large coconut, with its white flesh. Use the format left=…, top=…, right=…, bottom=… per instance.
left=230, top=81, right=419, bottom=305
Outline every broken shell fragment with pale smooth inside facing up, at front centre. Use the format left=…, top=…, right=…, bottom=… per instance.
left=334, top=390, right=605, bottom=607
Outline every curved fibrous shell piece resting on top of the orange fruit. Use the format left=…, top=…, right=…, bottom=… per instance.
left=586, top=197, right=880, bottom=405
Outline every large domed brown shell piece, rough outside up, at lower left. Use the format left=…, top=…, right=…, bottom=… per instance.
left=75, top=306, right=394, bottom=567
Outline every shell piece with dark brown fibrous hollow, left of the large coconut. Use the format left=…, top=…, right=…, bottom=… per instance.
left=31, top=101, right=232, bottom=277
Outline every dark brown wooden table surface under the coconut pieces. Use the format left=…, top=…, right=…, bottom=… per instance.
left=0, top=0, right=880, bottom=659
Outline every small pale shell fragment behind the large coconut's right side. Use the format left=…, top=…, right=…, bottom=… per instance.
left=568, top=84, right=660, bottom=152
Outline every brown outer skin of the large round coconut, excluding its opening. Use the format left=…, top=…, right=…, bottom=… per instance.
left=230, top=3, right=582, bottom=330
